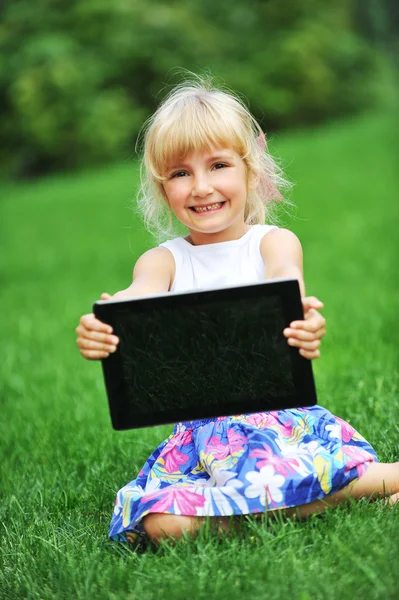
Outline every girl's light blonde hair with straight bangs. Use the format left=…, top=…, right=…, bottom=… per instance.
left=137, top=76, right=291, bottom=240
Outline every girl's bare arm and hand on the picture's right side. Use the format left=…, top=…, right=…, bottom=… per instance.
left=260, top=229, right=326, bottom=359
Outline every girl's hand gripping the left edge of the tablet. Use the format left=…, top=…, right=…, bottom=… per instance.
left=76, top=293, right=119, bottom=360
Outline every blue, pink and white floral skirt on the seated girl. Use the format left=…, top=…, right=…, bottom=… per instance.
left=110, top=406, right=377, bottom=541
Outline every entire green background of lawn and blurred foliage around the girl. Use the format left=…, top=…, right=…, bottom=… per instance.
left=0, top=0, right=399, bottom=600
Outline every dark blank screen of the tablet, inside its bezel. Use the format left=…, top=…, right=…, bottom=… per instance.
left=119, top=298, right=293, bottom=413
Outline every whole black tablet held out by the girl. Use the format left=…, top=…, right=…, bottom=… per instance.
left=93, top=279, right=317, bottom=430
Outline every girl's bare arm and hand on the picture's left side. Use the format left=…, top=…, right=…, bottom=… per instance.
left=76, top=248, right=175, bottom=360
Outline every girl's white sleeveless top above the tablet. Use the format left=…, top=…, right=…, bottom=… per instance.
left=160, top=225, right=276, bottom=292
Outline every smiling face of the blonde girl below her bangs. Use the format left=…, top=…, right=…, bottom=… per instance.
left=163, top=148, right=247, bottom=245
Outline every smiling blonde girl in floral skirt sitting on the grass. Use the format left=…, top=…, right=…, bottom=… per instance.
left=77, top=80, right=399, bottom=542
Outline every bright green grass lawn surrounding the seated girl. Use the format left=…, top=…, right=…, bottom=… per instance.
left=0, top=109, right=399, bottom=600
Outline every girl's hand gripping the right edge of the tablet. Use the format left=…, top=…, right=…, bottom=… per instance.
left=283, top=296, right=326, bottom=359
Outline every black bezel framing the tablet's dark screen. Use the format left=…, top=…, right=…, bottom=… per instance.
left=93, top=279, right=317, bottom=431
